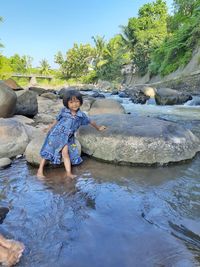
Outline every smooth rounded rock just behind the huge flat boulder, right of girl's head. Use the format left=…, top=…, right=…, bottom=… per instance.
left=88, top=99, right=125, bottom=115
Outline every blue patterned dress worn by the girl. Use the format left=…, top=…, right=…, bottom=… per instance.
left=40, top=108, right=90, bottom=165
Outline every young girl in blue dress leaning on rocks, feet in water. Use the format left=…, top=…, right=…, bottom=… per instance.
left=37, top=90, right=106, bottom=179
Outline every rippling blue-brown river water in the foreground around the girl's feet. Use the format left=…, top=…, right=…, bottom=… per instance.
left=0, top=155, right=200, bottom=267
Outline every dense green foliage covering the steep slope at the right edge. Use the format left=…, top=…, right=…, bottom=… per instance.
left=149, top=1, right=200, bottom=76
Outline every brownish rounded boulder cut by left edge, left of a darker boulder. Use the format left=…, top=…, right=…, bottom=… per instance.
left=0, top=81, right=17, bottom=118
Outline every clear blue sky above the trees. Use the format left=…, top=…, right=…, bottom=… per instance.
left=0, top=0, right=173, bottom=67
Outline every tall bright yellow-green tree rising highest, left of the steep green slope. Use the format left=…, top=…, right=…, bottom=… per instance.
left=122, top=0, right=168, bottom=75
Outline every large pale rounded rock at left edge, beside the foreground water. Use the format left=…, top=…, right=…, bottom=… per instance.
left=0, top=119, right=29, bottom=158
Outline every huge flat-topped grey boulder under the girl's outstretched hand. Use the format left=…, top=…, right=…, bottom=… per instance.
left=77, top=114, right=200, bottom=165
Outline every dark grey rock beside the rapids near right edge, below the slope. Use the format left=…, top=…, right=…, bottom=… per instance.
left=155, top=88, right=192, bottom=105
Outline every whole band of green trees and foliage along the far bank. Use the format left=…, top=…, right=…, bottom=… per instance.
left=0, top=0, right=200, bottom=83
